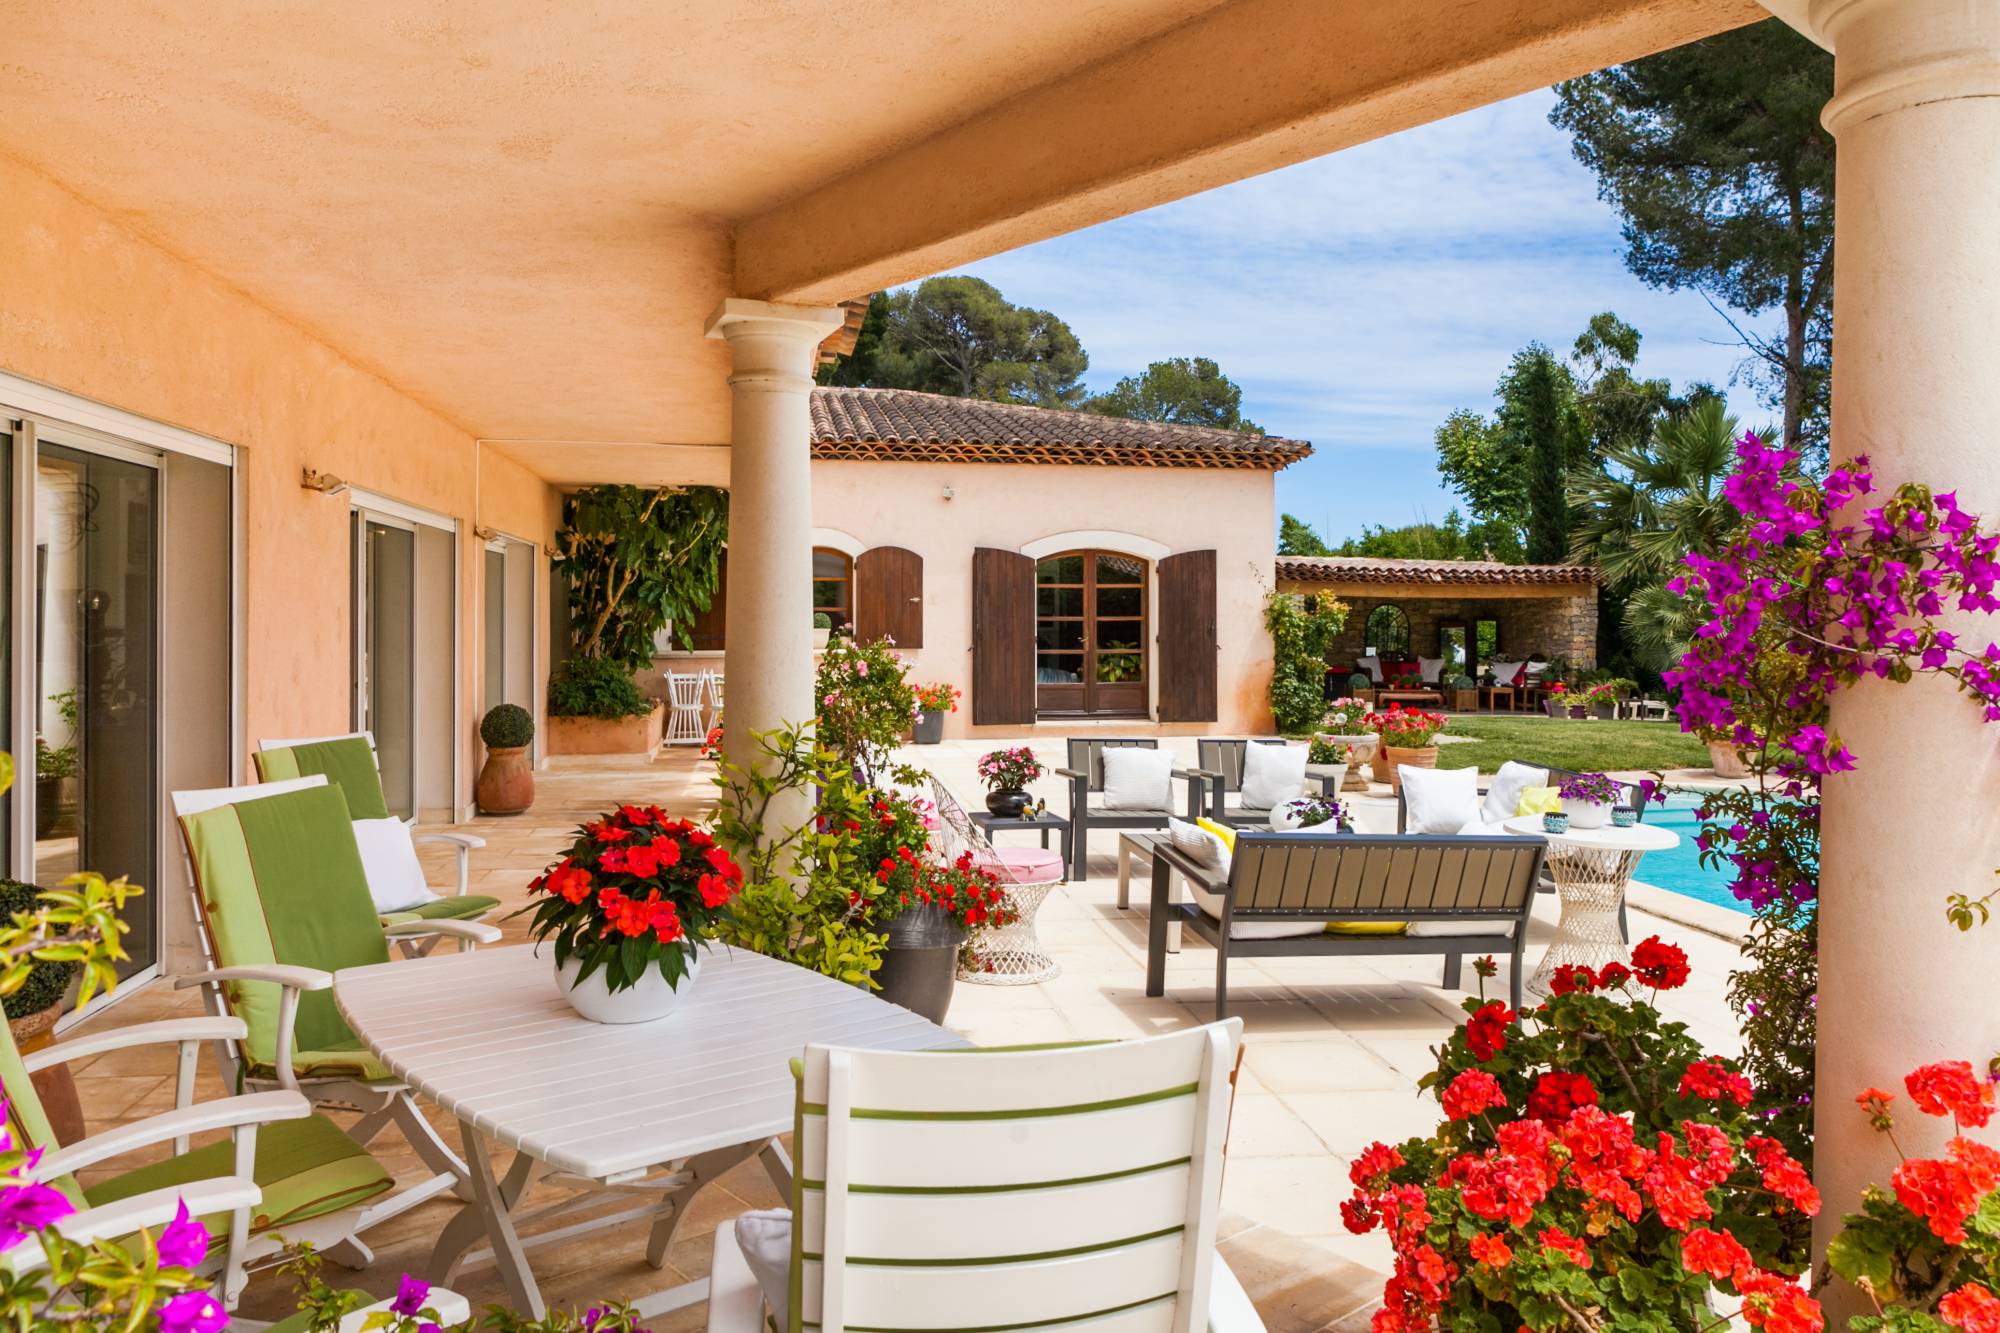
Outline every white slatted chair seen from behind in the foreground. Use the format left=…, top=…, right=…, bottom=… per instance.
left=708, top=1019, right=1264, bottom=1333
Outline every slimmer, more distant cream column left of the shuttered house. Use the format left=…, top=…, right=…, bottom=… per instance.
left=708, top=298, right=844, bottom=819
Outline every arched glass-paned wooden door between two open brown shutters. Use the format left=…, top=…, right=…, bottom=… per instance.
left=1034, top=550, right=1148, bottom=717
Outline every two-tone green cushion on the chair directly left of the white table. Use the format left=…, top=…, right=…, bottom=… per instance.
left=180, top=787, right=388, bottom=1073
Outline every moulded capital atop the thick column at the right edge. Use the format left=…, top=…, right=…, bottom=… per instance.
left=1808, top=0, right=2000, bottom=136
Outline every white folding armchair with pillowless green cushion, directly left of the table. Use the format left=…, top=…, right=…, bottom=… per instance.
left=174, top=775, right=500, bottom=1231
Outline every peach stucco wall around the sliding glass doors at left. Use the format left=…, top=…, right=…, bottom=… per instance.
left=0, top=158, right=556, bottom=801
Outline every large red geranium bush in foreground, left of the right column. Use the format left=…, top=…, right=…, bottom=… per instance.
left=1340, top=937, right=1824, bottom=1333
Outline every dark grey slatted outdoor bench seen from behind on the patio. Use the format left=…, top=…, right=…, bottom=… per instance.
left=1146, top=833, right=1544, bottom=1019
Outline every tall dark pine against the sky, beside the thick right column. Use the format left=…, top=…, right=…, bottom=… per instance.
left=1550, top=18, right=1834, bottom=456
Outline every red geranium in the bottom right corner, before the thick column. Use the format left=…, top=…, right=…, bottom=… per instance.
left=1826, top=1061, right=2000, bottom=1333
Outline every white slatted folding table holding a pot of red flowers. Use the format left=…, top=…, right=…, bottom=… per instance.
left=334, top=945, right=966, bottom=1319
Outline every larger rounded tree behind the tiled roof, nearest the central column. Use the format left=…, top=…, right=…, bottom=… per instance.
left=852, top=276, right=1090, bottom=408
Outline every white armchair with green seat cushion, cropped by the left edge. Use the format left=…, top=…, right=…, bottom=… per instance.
left=0, top=1000, right=394, bottom=1307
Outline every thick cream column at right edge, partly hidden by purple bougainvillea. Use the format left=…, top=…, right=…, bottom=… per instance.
left=1810, top=0, right=2000, bottom=1288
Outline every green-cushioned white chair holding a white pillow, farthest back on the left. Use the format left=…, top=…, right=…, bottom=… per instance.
left=256, top=731, right=500, bottom=944
